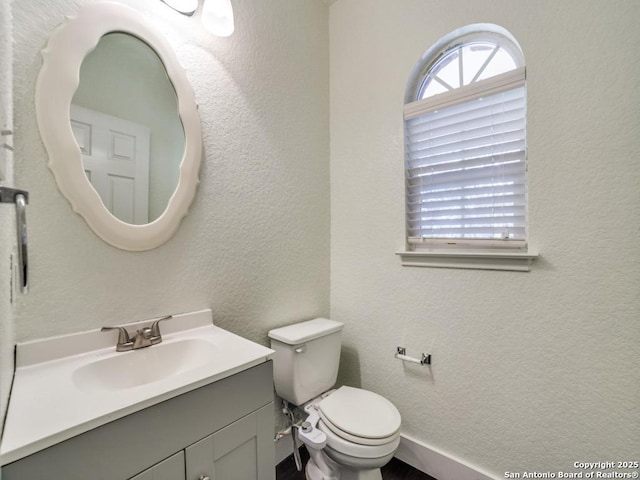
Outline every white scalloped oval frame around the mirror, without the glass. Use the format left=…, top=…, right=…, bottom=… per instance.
left=35, top=2, right=202, bottom=251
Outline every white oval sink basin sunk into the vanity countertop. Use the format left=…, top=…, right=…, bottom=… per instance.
left=72, top=338, right=216, bottom=391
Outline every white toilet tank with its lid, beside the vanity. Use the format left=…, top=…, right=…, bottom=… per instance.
left=269, top=318, right=344, bottom=405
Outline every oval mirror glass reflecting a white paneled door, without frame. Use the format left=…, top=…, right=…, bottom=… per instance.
left=70, top=32, right=184, bottom=225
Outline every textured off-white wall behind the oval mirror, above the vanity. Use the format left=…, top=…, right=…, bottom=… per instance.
left=13, top=0, right=329, bottom=352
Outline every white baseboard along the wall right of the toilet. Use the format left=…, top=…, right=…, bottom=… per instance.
left=395, top=435, right=498, bottom=480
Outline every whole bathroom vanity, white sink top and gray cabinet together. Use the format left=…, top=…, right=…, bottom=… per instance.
left=0, top=310, right=275, bottom=480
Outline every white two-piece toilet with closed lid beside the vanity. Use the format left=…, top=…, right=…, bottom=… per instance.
left=269, top=318, right=401, bottom=480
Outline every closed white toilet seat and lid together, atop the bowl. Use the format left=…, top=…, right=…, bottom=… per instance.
left=317, top=386, right=401, bottom=452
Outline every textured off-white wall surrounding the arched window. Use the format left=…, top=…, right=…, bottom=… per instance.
left=330, top=0, right=640, bottom=474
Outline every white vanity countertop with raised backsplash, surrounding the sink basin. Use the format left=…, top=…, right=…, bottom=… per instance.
left=0, top=310, right=274, bottom=465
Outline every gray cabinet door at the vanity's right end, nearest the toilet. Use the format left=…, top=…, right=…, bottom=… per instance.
left=185, top=404, right=275, bottom=480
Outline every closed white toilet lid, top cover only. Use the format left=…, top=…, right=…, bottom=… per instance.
left=318, top=387, right=401, bottom=439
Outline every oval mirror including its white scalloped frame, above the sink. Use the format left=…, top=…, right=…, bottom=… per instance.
left=36, top=3, right=202, bottom=250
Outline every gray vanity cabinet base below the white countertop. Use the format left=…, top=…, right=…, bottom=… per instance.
left=2, top=361, right=275, bottom=480
